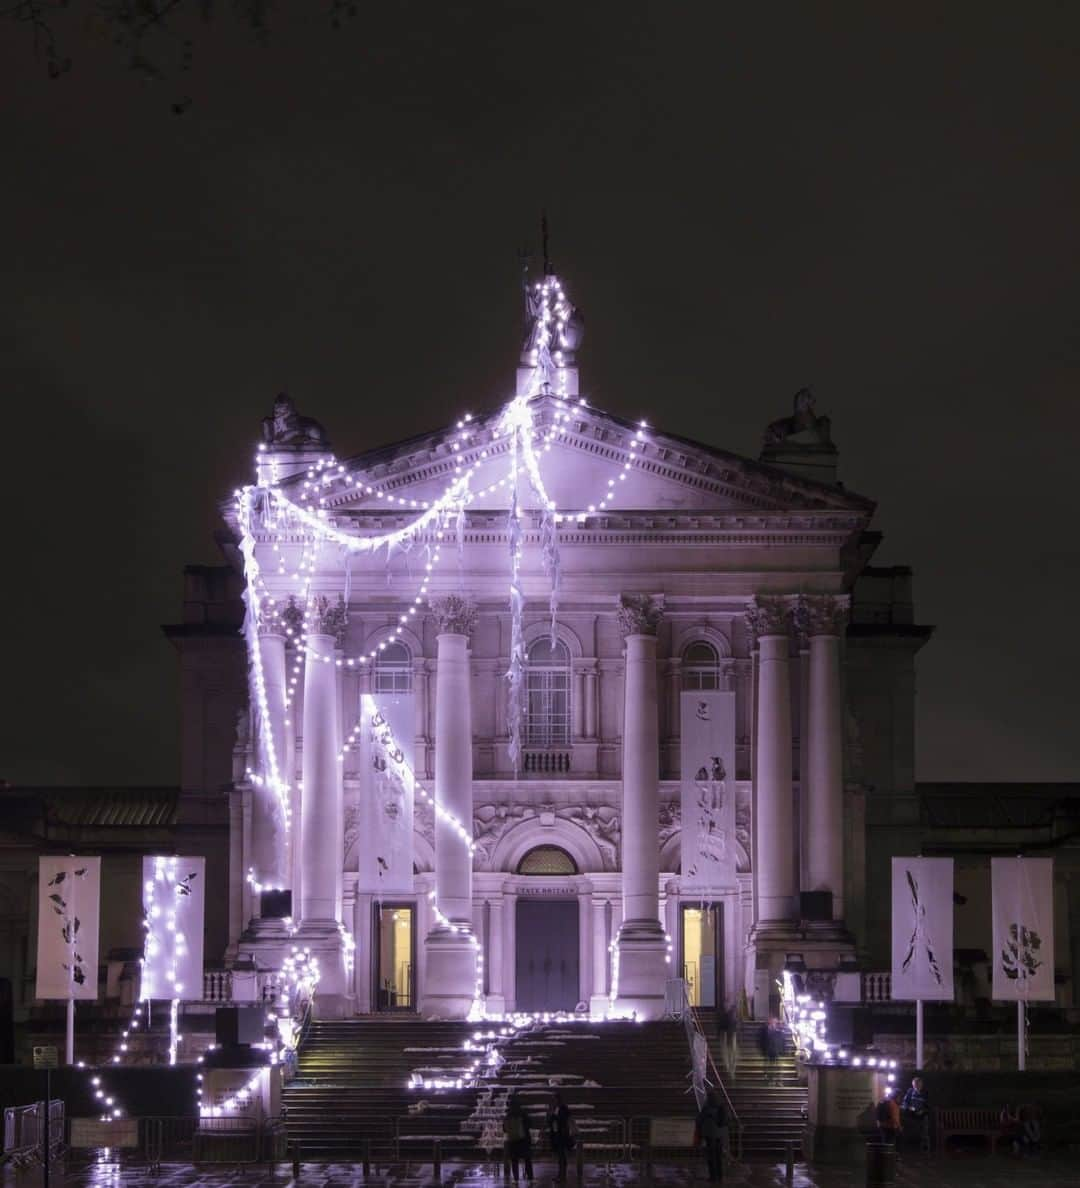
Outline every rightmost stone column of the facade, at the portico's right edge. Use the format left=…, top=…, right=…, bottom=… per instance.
left=802, top=595, right=848, bottom=920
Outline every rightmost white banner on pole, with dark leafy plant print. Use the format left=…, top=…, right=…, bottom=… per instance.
left=990, top=858, right=1055, bottom=1003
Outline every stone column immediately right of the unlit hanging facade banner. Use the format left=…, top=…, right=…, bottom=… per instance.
left=750, top=598, right=795, bottom=927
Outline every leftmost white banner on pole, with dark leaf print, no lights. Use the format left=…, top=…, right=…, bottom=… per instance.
left=34, top=855, right=101, bottom=1000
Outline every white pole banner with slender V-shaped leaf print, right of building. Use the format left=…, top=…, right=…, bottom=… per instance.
left=891, top=858, right=954, bottom=1003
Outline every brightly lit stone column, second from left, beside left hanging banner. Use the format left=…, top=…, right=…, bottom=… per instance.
left=299, top=595, right=346, bottom=1016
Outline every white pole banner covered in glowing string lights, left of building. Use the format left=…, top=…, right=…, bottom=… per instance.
left=139, top=854, right=207, bottom=999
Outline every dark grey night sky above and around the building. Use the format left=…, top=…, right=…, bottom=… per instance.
left=0, top=0, right=1080, bottom=783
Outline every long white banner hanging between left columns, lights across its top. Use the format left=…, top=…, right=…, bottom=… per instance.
left=356, top=693, right=416, bottom=895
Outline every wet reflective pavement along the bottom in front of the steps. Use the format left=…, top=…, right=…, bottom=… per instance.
left=0, top=1155, right=1080, bottom=1188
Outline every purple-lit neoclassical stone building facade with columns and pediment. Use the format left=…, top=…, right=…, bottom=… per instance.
left=206, top=323, right=929, bottom=1017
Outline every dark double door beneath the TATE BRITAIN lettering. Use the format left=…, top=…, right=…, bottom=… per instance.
left=517, top=899, right=579, bottom=1011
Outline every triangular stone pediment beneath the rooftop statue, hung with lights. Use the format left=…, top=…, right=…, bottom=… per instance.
left=293, top=397, right=873, bottom=516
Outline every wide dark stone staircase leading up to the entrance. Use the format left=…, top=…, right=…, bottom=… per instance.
left=284, top=1017, right=806, bottom=1162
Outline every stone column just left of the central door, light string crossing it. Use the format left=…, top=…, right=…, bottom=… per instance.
left=421, top=594, right=476, bottom=1019
